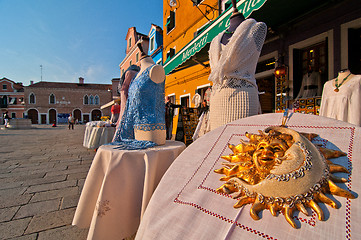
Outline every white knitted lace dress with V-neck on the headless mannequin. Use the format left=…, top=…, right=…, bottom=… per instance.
left=209, top=19, right=267, bottom=130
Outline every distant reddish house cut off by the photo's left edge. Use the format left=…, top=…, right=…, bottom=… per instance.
left=0, top=77, right=24, bottom=122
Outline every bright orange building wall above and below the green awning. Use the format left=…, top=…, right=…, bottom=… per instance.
left=163, top=0, right=219, bottom=134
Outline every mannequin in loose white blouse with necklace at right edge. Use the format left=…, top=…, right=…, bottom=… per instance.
left=320, top=70, right=361, bottom=126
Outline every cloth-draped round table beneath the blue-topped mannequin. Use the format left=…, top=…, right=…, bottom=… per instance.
left=73, top=141, right=185, bottom=240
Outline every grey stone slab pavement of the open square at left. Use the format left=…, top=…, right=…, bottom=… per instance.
left=0, top=125, right=95, bottom=240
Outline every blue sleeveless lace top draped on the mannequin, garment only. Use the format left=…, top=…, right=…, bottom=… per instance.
left=110, top=65, right=165, bottom=150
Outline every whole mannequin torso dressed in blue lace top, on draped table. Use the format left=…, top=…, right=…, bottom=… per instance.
left=111, top=44, right=166, bottom=149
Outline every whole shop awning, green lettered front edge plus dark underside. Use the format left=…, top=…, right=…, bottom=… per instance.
left=164, top=0, right=337, bottom=74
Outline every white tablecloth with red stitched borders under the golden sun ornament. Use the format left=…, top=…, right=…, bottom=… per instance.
left=136, top=113, right=361, bottom=240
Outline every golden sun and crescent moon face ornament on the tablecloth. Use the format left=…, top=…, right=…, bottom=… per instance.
left=215, top=127, right=355, bottom=228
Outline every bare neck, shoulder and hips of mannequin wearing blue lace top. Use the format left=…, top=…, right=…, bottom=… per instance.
left=134, top=43, right=166, bottom=145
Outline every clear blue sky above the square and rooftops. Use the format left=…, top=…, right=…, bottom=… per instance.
left=0, top=0, right=163, bottom=86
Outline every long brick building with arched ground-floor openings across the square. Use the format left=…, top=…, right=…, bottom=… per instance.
left=24, top=78, right=112, bottom=124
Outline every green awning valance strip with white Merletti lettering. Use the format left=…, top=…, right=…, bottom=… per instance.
left=164, top=0, right=267, bottom=74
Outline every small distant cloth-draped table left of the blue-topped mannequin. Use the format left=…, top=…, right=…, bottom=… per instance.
left=83, top=121, right=115, bottom=149
